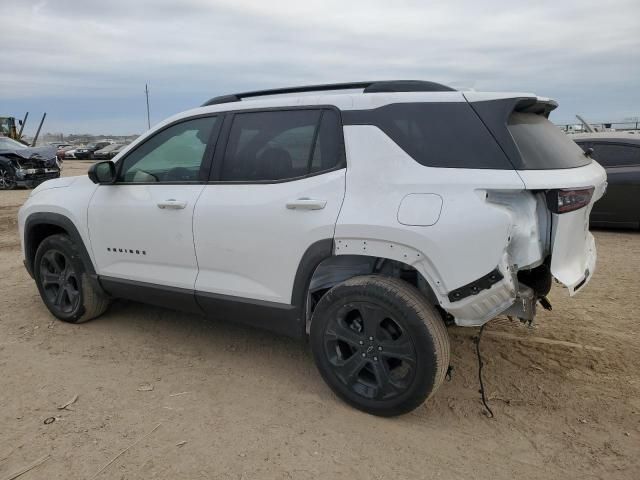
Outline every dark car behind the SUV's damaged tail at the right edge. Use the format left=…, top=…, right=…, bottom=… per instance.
left=571, top=132, right=640, bottom=228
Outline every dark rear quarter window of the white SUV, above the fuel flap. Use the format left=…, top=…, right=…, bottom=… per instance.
left=343, top=102, right=513, bottom=169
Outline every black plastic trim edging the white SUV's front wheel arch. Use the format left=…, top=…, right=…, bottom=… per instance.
left=24, top=212, right=96, bottom=278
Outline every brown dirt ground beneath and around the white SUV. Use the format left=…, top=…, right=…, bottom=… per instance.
left=0, top=161, right=640, bottom=480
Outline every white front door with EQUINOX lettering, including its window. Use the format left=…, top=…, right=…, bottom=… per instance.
left=88, top=116, right=221, bottom=304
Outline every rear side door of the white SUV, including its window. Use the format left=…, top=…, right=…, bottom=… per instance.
left=194, top=108, right=346, bottom=330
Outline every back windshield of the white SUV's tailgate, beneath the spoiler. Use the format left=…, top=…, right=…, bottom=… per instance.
left=507, top=112, right=591, bottom=170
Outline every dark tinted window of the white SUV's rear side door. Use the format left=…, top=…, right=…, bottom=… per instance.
left=221, top=110, right=341, bottom=181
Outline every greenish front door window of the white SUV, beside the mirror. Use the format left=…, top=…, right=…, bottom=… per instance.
left=118, top=117, right=218, bottom=183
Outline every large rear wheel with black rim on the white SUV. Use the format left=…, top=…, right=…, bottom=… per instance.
left=310, top=275, right=449, bottom=417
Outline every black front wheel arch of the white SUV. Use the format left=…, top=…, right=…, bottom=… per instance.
left=24, top=212, right=95, bottom=277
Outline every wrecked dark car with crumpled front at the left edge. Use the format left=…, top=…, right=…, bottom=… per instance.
left=0, top=137, right=60, bottom=190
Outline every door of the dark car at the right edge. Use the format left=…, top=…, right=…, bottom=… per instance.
left=590, top=142, right=640, bottom=226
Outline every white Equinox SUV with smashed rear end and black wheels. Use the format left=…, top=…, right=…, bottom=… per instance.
left=19, top=81, right=606, bottom=415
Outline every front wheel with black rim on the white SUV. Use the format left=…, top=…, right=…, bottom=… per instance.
left=33, top=234, right=109, bottom=323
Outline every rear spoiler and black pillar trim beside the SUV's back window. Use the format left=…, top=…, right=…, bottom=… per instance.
left=464, top=93, right=558, bottom=170
